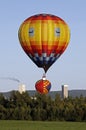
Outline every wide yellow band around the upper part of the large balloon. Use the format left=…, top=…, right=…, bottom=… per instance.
left=19, top=20, right=70, bottom=51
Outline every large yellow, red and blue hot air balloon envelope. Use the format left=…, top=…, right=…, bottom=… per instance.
left=18, top=14, right=70, bottom=72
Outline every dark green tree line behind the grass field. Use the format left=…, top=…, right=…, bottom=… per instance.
left=0, top=91, right=86, bottom=121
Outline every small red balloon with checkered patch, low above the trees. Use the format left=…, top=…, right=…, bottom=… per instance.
left=35, top=79, right=51, bottom=94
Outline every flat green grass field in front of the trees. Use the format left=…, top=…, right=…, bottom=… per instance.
left=0, top=120, right=86, bottom=130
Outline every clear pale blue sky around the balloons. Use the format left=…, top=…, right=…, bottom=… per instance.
left=0, top=0, right=86, bottom=91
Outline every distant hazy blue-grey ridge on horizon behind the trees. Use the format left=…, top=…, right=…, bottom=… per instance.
left=0, top=90, right=86, bottom=99
